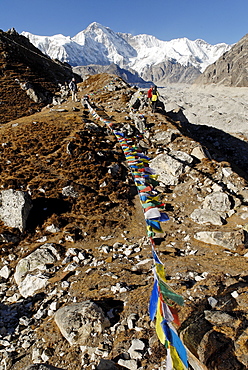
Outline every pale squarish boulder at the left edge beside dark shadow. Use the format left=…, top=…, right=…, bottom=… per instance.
left=0, top=189, right=33, bottom=232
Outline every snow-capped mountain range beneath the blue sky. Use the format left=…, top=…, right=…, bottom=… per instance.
left=22, top=22, right=231, bottom=83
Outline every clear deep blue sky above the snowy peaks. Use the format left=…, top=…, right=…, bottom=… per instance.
left=0, top=0, right=248, bottom=44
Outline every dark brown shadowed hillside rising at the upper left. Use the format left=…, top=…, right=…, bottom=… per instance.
left=0, top=30, right=81, bottom=123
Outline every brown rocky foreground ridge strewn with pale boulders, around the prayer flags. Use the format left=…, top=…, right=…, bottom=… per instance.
left=0, top=74, right=248, bottom=370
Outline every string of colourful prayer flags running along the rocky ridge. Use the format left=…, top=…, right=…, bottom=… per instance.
left=84, top=97, right=188, bottom=370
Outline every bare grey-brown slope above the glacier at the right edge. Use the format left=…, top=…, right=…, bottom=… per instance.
left=194, top=34, right=248, bottom=87
